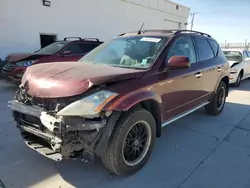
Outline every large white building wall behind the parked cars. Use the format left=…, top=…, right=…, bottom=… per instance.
left=0, top=0, right=189, bottom=59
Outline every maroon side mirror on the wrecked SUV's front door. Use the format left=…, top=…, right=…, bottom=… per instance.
left=167, top=56, right=190, bottom=69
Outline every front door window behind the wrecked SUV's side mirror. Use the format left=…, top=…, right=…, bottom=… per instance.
left=167, top=37, right=197, bottom=63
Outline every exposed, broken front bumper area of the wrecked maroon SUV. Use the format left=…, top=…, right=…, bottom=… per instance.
left=8, top=100, right=119, bottom=161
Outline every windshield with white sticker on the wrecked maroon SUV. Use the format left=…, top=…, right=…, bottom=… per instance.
left=79, top=36, right=168, bottom=69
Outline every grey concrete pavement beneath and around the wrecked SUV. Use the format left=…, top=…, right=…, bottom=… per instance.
left=0, top=80, right=250, bottom=188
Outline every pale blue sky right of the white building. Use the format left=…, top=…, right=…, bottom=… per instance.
left=173, top=0, right=250, bottom=42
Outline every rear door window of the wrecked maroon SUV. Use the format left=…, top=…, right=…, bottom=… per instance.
left=194, top=37, right=214, bottom=61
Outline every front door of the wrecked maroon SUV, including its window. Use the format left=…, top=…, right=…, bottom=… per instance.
left=162, top=35, right=202, bottom=120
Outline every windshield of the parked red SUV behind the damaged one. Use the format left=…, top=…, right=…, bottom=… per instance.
left=35, top=41, right=69, bottom=55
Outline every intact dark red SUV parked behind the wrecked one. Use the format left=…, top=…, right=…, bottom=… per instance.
left=1, top=37, right=102, bottom=84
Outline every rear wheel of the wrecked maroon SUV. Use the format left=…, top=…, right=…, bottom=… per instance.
left=205, top=81, right=227, bottom=116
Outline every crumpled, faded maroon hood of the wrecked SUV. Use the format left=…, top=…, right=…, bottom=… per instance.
left=22, top=62, right=144, bottom=98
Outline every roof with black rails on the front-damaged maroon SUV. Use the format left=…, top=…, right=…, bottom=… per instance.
left=118, top=29, right=212, bottom=38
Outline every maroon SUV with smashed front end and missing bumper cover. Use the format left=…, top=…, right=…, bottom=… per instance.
left=8, top=30, right=229, bottom=176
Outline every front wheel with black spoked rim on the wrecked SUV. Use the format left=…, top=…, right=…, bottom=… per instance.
left=102, top=108, right=156, bottom=176
